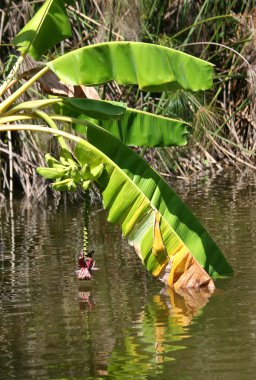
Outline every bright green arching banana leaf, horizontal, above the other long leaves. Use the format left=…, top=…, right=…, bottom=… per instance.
left=47, top=41, right=213, bottom=92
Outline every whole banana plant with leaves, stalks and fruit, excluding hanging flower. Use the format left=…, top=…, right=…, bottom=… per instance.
left=0, top=0, right=232, bottom=288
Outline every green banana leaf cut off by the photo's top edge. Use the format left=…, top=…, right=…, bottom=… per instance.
left=13, top=0, right=72, bottom=59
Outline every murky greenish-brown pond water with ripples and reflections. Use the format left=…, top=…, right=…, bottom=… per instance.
left=0, top=173, right=256, bottom=380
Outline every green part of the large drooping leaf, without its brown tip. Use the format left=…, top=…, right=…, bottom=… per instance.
left=75, top=126, right=232, bottom=276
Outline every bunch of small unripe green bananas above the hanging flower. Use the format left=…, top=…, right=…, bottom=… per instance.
left=36, top=151, right=104, bottom=191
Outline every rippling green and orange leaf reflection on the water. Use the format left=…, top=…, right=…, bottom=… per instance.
left=107, top=288, right=211, bottom=379
